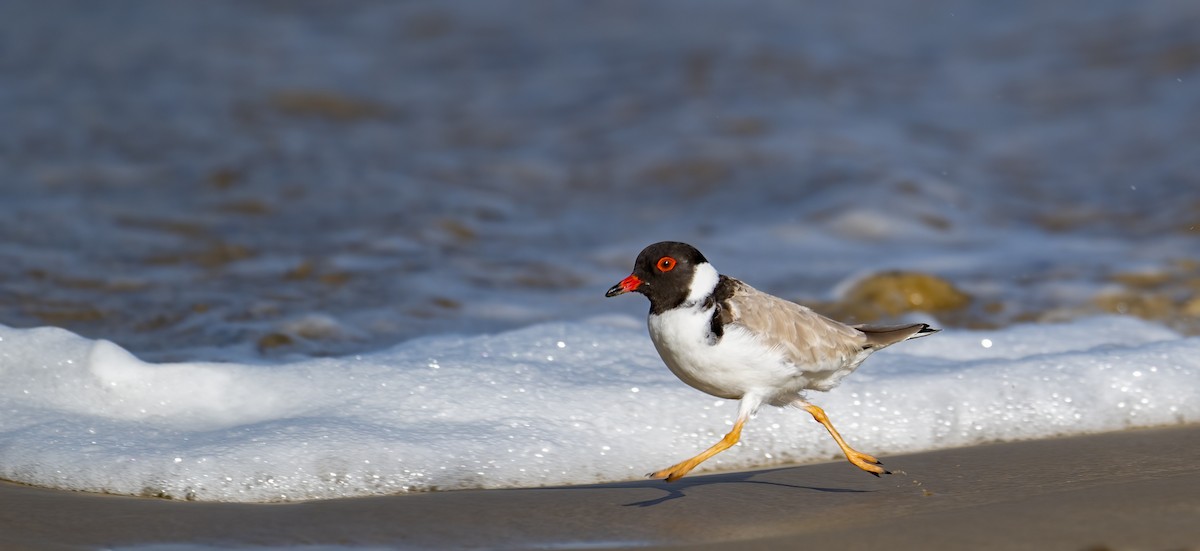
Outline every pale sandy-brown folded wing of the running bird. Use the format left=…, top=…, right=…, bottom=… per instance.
left=722, top=280, right=866, bottom=371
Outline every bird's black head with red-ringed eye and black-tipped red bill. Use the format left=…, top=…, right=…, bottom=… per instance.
left=605, top=241, right=708, bottom=313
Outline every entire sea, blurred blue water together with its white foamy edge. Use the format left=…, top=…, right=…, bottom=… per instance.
left=0, top=1, right=1200, bottom=501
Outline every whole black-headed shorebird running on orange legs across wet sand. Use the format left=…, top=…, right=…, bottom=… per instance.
left=605, top=241, right=938, bottom=481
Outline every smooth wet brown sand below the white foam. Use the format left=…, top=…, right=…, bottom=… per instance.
left=0, top=425, right=1200, bottom=551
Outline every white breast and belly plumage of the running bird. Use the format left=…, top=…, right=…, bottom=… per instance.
left=648, top=307, right=806, bottom=400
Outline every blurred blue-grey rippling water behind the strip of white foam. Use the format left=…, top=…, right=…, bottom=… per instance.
left=0, top=1, right=1200, bottom=360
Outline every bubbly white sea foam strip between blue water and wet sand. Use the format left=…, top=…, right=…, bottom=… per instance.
left=0, top=317, right=1200, bottom=502
